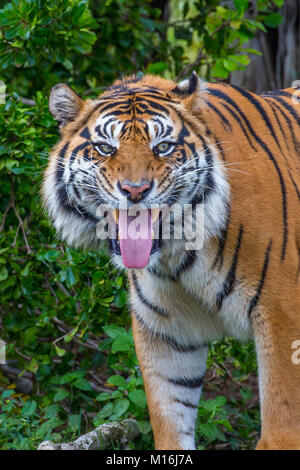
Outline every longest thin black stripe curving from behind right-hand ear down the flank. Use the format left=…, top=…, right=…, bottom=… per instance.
left=207, top=88, right=288, bottom=261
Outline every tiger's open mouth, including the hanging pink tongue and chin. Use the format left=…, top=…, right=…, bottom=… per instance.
left=110, top=208, right=161, bottom=269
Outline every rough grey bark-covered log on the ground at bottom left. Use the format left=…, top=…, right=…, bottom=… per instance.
left=37, top=419, right=140, bottom=450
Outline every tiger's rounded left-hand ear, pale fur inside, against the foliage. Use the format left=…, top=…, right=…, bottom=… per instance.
left=49, top=83, right=84, bottom=127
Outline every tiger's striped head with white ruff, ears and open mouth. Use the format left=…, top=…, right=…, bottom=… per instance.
left=42, top=73, right=228, bottom=268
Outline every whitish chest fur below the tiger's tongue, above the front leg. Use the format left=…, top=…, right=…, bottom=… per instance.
left=131, top=242, right=252, bottom=344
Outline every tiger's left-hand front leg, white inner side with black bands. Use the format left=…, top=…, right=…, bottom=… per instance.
left=133, top=313, right=207, bottom=450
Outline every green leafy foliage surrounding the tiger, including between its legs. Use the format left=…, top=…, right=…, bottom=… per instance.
left=0, top=0, right=282, bottom=449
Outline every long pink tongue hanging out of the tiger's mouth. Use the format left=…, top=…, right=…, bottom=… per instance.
left=119, top=210, right=152, bottom=268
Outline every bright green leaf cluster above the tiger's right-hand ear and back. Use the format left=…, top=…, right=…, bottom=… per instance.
left=169, top=0, right=283, bottom=80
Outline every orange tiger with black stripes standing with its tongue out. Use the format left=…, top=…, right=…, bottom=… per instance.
left=42, top=72, right=300, bottom=450
